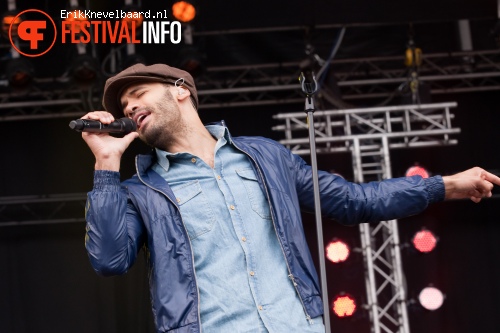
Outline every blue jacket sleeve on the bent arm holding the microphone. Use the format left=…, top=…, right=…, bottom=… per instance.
left=85, top=170, right=144, bottom=276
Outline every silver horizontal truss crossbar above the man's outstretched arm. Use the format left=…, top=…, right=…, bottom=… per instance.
left=273, top=102, right=460, bottom=155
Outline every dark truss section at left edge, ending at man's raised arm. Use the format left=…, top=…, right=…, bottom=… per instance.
left=0, top=193, right=87, bottom=227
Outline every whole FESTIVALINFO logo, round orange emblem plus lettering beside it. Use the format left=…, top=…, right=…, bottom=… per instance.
left=9, top=9, right=182, bottom=57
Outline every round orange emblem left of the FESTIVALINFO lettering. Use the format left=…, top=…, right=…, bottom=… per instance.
left=9, top=9, right=57, bottom=57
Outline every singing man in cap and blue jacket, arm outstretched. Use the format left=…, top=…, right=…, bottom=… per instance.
left=82, top=64, right=500, bottom=333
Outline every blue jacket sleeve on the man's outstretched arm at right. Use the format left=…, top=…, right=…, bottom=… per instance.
left=290, top=147, right=445, bottom=225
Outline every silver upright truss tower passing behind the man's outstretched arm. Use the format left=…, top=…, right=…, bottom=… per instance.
left=353, top=137, right=410, bottom=333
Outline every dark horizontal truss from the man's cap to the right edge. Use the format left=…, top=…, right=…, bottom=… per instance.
left=197, top=50, right=500, bottom=109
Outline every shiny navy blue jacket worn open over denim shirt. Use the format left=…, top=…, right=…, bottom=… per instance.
left=85, top=127, right=444, bottom=333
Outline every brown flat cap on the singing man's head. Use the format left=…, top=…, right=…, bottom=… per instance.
left=102, top=64, right=198, bottom=115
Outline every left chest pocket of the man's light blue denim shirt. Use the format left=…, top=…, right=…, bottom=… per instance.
left=173, top=180, right=215, bottom=240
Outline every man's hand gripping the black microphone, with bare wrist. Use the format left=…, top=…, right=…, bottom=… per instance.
left=82, top=111, right=139, bottom=171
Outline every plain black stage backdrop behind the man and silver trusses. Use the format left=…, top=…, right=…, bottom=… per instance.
left=0, top=92, right=500, bottom=333
